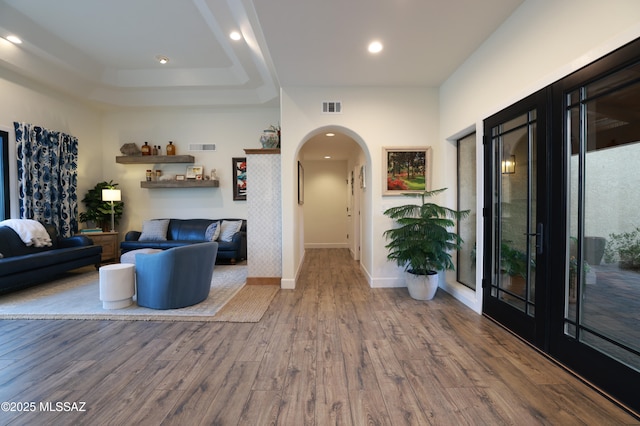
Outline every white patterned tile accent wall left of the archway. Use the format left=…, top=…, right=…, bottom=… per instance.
left=247, top=150, right=282, bottom=277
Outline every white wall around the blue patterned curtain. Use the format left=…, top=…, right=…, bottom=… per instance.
left=0, top=68, right=102, bottom=218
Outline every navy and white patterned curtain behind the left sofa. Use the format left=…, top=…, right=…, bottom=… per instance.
left=13, top=123, right=78, bottom=237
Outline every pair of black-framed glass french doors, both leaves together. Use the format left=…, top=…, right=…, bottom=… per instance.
left=483, top=39, right=640, bottom=412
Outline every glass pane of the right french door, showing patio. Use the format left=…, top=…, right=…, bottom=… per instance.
left=564, top=65, right=640, bottom=371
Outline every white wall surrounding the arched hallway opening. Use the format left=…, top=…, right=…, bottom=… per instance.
left=281, top=87, right=440, bottom=288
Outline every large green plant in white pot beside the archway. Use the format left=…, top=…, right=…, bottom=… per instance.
left=383, top=188, right=469, bottom=300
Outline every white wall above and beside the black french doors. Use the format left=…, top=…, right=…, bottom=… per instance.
left=439, top=0, right=640, bottom=312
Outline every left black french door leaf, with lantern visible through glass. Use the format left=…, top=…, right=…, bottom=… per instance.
left=483, top=91, right=549, bottom=347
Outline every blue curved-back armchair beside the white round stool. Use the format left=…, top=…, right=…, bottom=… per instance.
left=136, top=242, right=218, bottom=309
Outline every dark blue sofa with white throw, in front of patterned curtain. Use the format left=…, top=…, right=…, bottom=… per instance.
left=0, top=221, right=102, bottom=294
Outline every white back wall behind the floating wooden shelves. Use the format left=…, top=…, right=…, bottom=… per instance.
left=101, top=108, right=279, bottom=236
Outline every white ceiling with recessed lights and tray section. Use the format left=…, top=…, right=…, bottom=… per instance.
left=0, top=0, right=523, bottom=106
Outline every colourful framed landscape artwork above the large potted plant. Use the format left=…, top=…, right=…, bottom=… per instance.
left=382, top=146, right=431, bottom=195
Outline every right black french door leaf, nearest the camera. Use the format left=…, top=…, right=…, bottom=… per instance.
left=549, top=40, right=640, bottom=412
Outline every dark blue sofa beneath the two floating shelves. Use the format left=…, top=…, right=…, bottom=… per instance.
left=120, top=219, right=247, bottom=264
